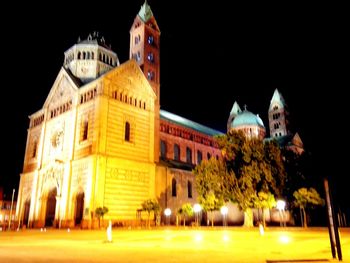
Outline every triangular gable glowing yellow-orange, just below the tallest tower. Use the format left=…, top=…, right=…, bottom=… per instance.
left=103, top=59, right=156, bottom=99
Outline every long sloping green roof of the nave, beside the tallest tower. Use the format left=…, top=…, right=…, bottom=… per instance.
left=160, top=110, right=223, bottom=136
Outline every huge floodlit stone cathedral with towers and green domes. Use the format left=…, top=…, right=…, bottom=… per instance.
left=16, top=2, right=302, bottom=228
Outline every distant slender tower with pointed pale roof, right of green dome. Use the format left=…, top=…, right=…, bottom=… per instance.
left=269, top=89, right=290, bottom=138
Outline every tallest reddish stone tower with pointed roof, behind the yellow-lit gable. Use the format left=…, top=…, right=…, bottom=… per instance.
left=129, top=0, right=160, bottom=162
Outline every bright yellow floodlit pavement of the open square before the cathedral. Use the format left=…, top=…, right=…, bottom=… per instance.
left=0, top=227, right=350, bottom=263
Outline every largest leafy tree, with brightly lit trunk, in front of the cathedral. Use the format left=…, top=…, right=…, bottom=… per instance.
left=216, top=131, right=285, bottom=227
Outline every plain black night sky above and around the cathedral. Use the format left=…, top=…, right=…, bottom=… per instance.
left=0, top=0, right=349, bottom=206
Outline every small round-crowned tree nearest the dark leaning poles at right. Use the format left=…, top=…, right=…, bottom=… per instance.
left=293, top=187, right=324, bottom=228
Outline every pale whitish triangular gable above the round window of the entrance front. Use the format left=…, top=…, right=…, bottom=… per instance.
left=43, top=68, right=78, bottom=108
